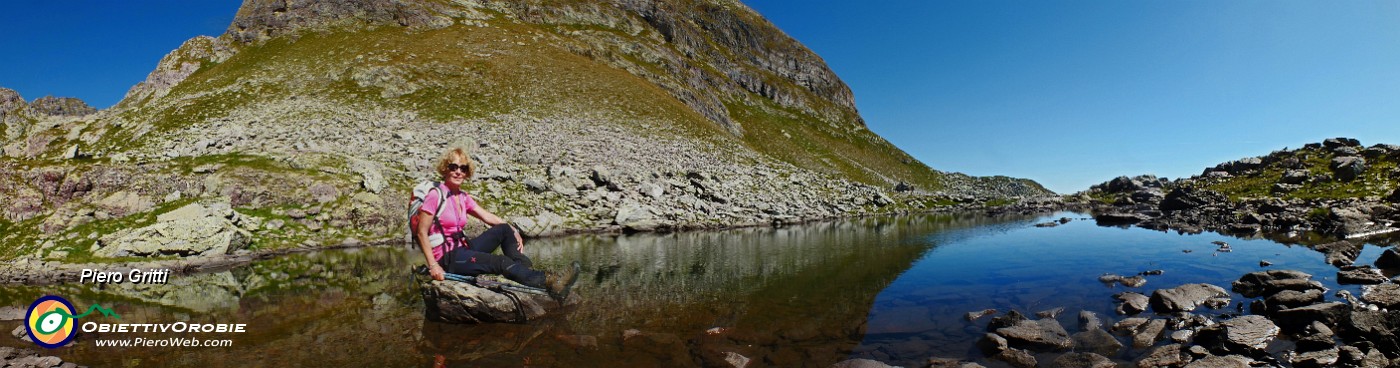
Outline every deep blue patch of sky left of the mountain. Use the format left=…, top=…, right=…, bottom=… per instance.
left=0, top=0, right=242, bottom=109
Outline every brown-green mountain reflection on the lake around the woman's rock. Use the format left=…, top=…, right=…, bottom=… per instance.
left=0, top=215, right=1029, bottom=367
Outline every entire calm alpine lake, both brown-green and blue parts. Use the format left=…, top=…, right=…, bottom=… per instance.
left=0, top=213, right=1385, bottom=368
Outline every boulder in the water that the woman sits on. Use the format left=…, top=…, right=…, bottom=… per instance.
left=419, top=276, right=580, bottom=323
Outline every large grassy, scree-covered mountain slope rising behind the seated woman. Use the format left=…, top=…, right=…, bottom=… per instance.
left=0, top=0, right=1049, bottom=260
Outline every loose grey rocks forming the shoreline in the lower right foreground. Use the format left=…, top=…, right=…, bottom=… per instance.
left=932, top=265, right=1400, bottom=368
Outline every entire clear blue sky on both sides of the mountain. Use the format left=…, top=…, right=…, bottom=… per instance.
left=0, top=0, right=1400, bottom=193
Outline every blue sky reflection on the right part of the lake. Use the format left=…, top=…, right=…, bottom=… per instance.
left=853, top=214, right=1383, bottom=367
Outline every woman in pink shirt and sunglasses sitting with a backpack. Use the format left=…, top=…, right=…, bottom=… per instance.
left=414, top=147, right=578, bottom=298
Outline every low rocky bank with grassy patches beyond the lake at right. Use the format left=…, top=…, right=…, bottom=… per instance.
left=1079, top=139, right=1400, bottom=242
